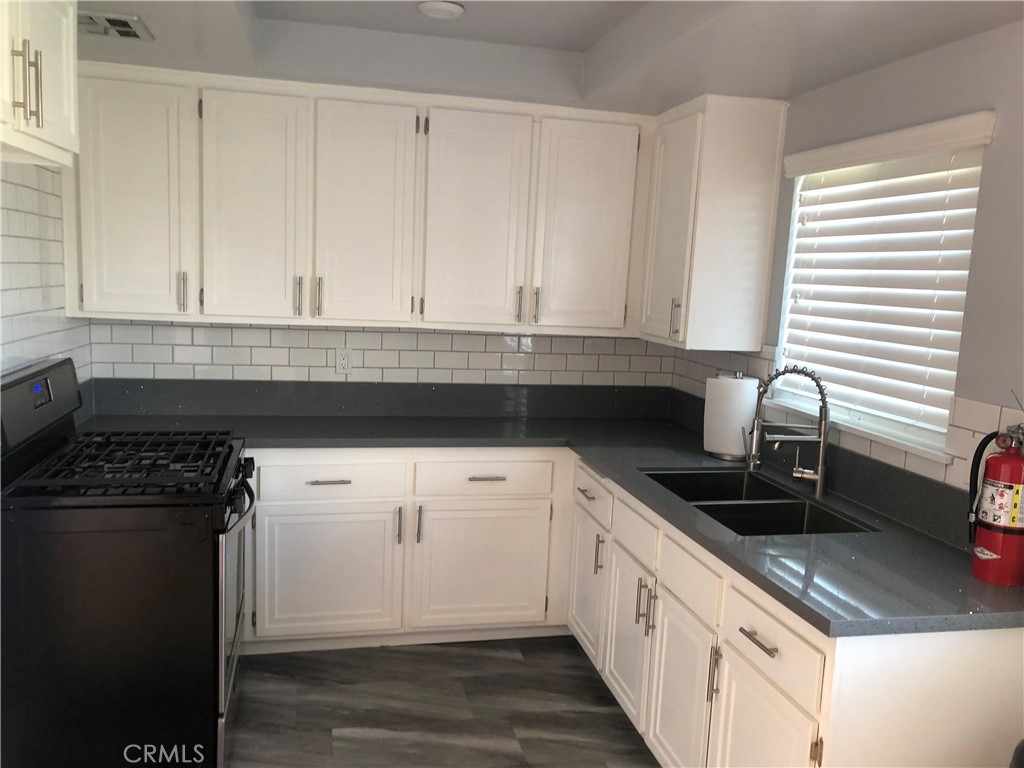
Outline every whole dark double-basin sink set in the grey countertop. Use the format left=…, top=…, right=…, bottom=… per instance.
left=641, top=470, right=877, bottom=536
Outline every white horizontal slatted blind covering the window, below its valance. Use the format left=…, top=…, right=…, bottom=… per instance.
left=777, top=146, right=982, bottom=451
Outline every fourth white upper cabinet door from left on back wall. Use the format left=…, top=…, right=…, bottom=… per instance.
left=423, top=110, right=532, bottom=325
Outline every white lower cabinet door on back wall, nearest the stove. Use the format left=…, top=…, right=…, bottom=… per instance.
left=256, top=502, right=408, bottom=637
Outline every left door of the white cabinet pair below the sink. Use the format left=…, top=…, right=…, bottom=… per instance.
left=603, top=542, right=654, bottom=733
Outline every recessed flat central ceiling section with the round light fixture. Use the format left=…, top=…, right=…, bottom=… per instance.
left=254, top=0, right=646, bottom=53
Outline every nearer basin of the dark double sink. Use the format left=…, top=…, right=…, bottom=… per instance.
left=696, top=500, right=878, bottom=536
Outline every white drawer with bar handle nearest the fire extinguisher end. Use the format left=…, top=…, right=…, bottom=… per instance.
left=722, top=587, right=824, bottom=713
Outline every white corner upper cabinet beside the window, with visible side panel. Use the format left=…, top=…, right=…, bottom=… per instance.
left=640, top=96, right=786, bottom=350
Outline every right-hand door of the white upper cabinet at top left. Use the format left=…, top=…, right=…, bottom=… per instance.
left=10, top=2, right=79, bottom=153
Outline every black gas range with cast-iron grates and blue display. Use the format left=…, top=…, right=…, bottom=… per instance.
left=0, top=359, right=254, bottom=768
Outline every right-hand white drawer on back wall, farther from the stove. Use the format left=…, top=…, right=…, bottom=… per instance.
left=416, top=461, right=552, bottom=497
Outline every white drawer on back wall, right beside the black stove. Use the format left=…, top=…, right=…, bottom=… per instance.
left=259, top=462, right=408, bottom=502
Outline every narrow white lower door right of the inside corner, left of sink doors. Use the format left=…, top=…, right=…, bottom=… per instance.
left=569, top=505, right=608, bottom=669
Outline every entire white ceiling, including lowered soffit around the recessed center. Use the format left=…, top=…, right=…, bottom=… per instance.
left=79, top=0, right=1024, bottom=114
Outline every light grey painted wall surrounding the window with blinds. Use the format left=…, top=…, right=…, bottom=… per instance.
left=766, top=24, right=1024, bottom=409
